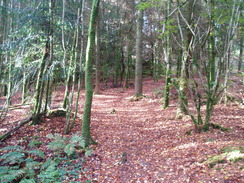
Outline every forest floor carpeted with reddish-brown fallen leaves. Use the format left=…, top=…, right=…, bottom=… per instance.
left=0, top=75, right=244, bottom=183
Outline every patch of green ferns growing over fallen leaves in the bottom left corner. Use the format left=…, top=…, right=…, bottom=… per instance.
left=0, top=134, right=91, bottom=183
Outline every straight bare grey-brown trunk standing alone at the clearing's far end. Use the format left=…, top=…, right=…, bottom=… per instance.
left=134, top=5, right=143, bottom=97
